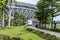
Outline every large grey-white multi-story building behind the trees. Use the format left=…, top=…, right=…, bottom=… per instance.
left=8, top=2, right=37, bottom=20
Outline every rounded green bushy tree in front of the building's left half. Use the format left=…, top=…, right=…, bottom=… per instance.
left=11, top=12, right=25, bottom=25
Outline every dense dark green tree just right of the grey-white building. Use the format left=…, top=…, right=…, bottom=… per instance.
left=35, top=0, right=49, bottom=27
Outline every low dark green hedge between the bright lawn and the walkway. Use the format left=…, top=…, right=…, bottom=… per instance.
left=27, top=28, right=59, bottom=40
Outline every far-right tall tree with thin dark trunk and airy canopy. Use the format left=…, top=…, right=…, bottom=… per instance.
left=44, top=0, right=60, bottom=28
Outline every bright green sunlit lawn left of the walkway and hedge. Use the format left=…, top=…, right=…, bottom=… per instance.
left=0, top=26, right=44, bottom=40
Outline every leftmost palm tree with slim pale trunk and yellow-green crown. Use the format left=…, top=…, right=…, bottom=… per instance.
left=0, top=0, right=8, bottom=28
